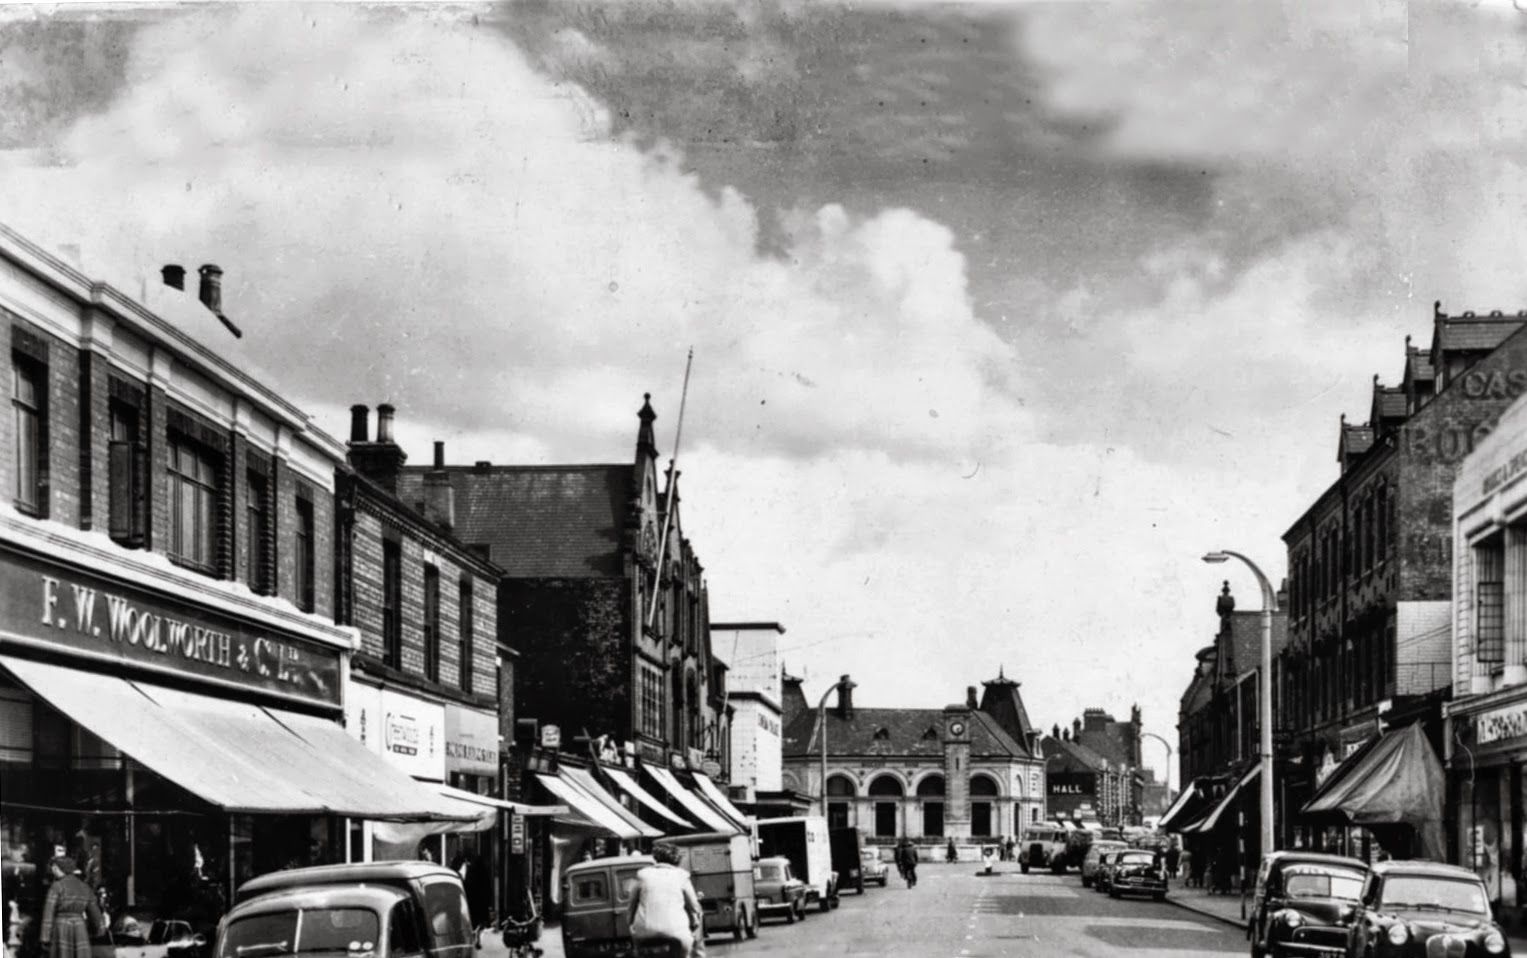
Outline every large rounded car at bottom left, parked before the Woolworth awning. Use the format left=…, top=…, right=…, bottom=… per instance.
left=214, top=862, right=476, bottom=958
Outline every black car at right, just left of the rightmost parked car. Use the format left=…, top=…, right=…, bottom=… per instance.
left=1246, top=851, right=1368, bottom=958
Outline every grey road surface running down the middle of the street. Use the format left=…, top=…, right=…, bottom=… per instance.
left=478, top=863, right=1246, bottom=958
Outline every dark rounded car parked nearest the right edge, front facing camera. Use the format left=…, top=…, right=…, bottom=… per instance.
left=1347, top=862, right=1512, bottom=958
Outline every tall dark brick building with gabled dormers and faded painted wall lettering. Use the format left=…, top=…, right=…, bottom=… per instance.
left=1274, top=304, right=1527, bottom=853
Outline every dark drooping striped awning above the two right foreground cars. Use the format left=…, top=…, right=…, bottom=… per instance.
left=1301, top=723, right=1445, bottom=857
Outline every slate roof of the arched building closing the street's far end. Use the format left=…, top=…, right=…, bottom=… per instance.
left=783, top=707, right=1031, bottom=758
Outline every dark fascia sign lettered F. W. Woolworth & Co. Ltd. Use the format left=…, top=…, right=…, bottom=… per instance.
left=0, top=553, right=339, bottom=704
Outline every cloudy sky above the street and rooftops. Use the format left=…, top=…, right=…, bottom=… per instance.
left=0, top=0, right=1527, bottom=788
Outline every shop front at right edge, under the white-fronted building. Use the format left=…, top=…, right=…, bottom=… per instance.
left=1448, top=686, right=1527, bottom=927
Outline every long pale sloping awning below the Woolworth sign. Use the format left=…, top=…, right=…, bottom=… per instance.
left=0, top=655, right=481, bottom=822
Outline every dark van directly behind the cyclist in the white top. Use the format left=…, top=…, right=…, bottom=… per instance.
left=562, top=856, right=667, bottom=958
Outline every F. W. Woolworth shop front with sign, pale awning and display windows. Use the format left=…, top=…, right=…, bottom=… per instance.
left=0, top=530, right=467, bottom=958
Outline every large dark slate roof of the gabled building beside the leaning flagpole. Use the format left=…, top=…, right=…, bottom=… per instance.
left=399, top=463, right=635, bottom=579
